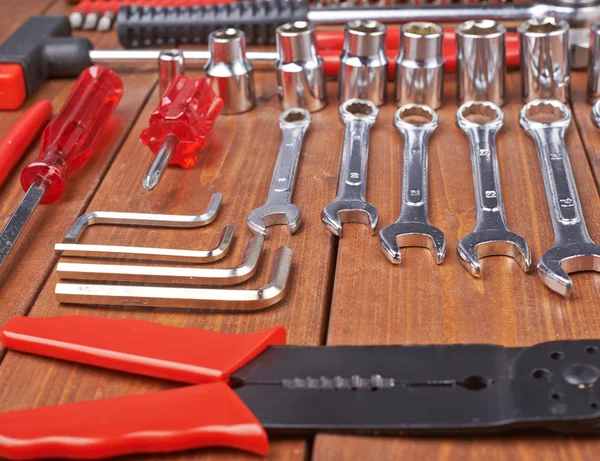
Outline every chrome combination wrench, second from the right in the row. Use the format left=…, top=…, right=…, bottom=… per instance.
left=456, top=101, right=531, bottom=277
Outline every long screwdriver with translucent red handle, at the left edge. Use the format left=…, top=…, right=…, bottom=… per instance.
left=0, top=66, right=123, bottom=266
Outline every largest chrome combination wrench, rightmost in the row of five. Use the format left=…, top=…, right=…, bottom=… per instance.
left=519, top=99, right=600, bottom=296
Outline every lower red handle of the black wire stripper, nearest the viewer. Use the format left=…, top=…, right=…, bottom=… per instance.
left=0, top=383, right=269, bottom=460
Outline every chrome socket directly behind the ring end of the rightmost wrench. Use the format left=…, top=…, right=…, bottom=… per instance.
left=518, top=17, right=571, bottom=102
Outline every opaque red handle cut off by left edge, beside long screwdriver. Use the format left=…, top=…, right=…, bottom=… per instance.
left=0, top=99, right=52, bottom=186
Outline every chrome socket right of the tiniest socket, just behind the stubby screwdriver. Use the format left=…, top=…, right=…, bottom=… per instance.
left=204, top=29, right=255, bottom=115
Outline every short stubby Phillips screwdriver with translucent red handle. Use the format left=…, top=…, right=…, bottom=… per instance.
left=140, top=75, right=223, bottom=190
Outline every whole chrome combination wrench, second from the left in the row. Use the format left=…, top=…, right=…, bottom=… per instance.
left=321, top=99, right=379, bottom=237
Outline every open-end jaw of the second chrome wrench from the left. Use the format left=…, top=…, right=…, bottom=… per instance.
left=321, top=200, right=379, bottom=237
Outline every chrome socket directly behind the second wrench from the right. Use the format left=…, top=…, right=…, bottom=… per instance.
left=456, top=19, right=506, bottom=106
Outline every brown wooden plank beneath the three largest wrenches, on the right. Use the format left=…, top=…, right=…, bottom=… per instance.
left=313, top=73, right=600, bottom=461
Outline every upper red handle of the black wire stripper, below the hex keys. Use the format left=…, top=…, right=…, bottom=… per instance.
left=0, top=315, right=286, bottom=383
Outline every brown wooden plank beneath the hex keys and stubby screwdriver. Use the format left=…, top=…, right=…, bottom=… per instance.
left=0, top=74, right=342, bottom=460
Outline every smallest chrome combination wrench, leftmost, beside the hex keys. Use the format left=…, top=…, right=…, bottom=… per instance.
left=246, top=108, right=310, bottom=238
